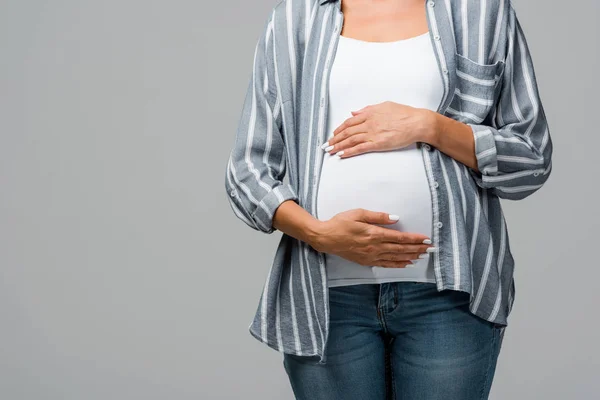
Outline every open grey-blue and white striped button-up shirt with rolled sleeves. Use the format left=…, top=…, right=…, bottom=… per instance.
left=225, top=0, right=552, bottom=364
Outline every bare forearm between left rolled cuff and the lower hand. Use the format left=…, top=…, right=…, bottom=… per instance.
left=273, top=200, right=322, bottom=246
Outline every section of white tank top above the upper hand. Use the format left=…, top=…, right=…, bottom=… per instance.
left=327, top=32, right=444, bottom=112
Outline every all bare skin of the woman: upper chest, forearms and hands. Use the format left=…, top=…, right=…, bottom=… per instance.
left=273, top=0, right=477, bottom=268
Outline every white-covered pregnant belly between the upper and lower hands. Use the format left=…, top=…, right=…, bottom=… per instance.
left=317, top=144, right=432, bottom=237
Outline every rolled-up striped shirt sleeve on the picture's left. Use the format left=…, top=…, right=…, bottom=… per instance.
left=225, top=10, right=298, bottom=233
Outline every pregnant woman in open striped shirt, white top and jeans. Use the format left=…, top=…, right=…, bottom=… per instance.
left=225, top=0, right=552, bottom=400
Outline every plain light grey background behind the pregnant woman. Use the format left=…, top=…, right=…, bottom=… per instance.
left=0, top=0, right=600, bottom=400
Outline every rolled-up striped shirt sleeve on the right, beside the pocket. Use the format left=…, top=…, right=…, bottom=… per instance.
left=468, top=2, right=552, bottom=200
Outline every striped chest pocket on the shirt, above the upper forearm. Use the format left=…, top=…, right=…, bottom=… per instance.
left=447, top=53, right=504, bottom=124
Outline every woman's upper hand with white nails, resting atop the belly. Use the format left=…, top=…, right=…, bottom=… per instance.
left=321, top=101, right=436, bottom=158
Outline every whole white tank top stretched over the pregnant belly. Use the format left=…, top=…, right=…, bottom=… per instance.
left=317, top=32, right=443, bottom=287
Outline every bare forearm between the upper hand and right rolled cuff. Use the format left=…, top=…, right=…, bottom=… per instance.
left=421, top=111, right=478, bottom=171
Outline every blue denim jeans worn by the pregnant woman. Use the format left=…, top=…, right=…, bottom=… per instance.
left=283, top=281, right=504, bottom=400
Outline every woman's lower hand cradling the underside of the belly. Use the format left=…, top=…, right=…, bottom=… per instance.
left=309, top=208, right=437, bottom=268
